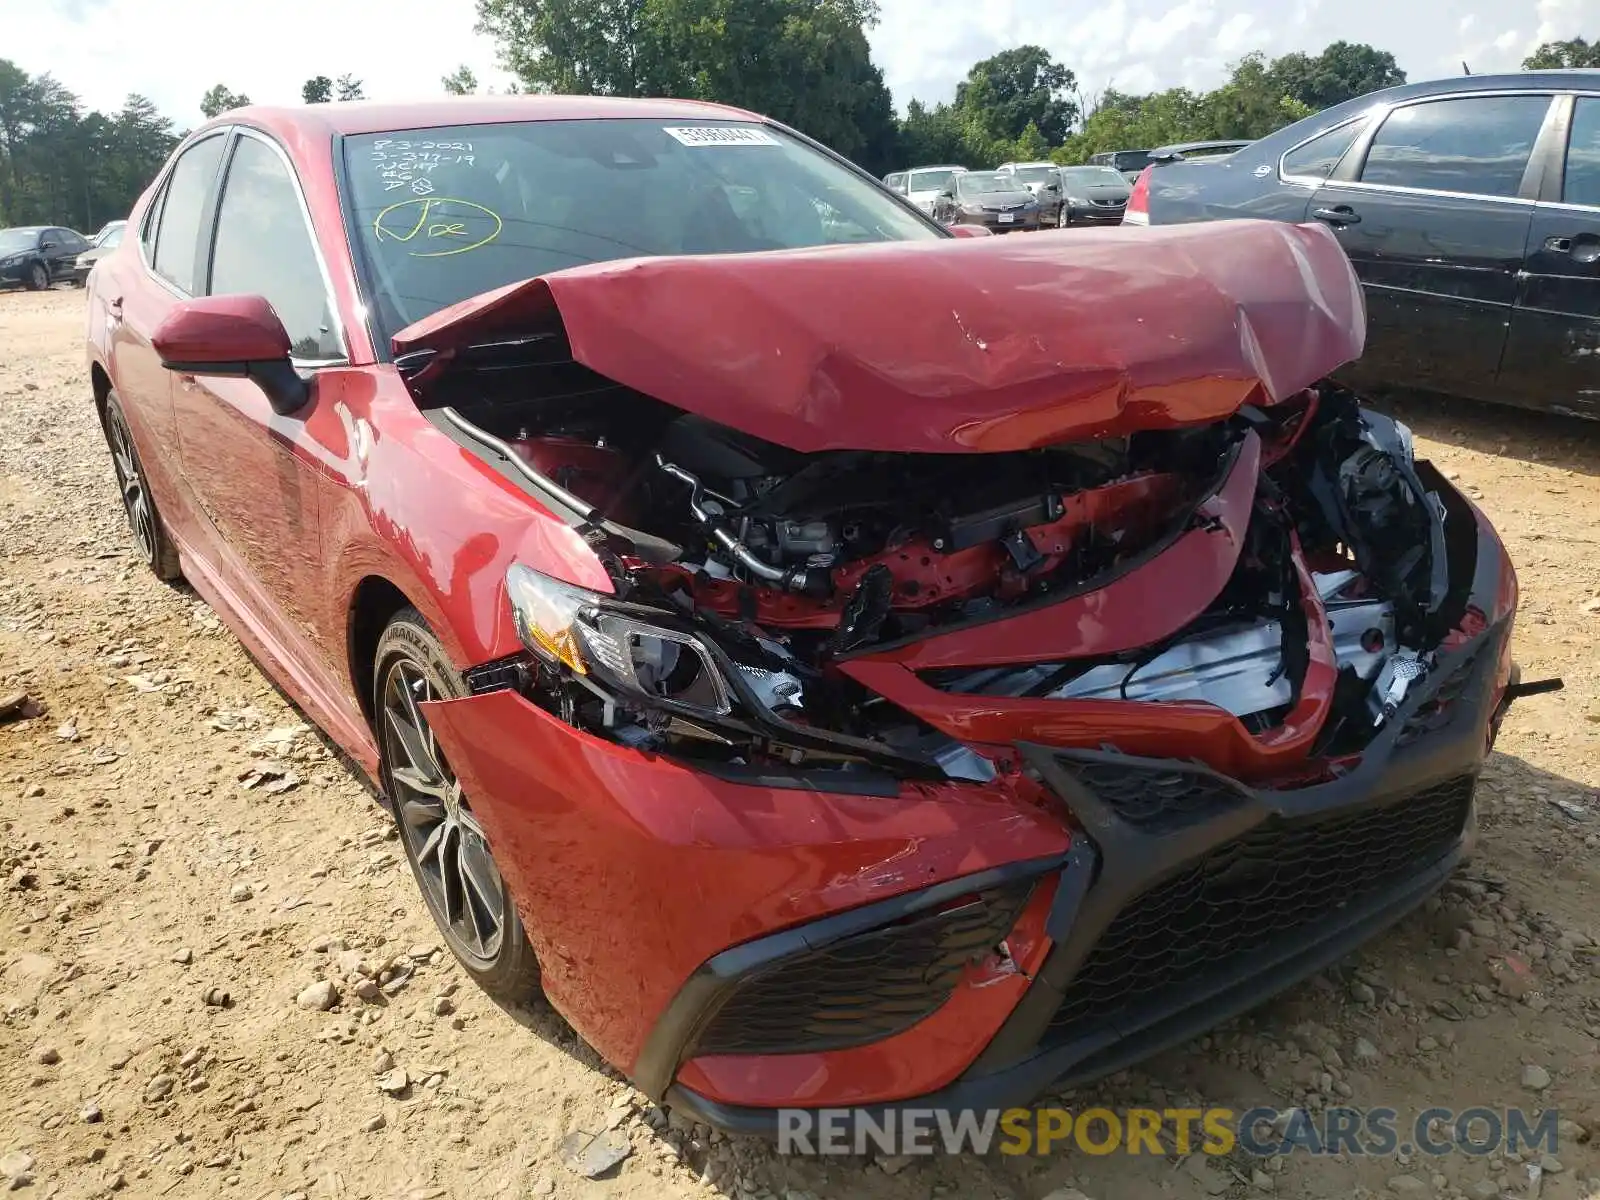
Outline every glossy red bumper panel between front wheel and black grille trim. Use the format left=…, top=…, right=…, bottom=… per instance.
left=424, top=691, right=1070, bottom=1069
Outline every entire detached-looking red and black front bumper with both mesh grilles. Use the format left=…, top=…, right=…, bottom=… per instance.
left=426, top=482, right=1515, bottom=1133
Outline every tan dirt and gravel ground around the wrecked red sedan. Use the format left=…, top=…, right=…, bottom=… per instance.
left=0, top=290, right=1600, bottom=1200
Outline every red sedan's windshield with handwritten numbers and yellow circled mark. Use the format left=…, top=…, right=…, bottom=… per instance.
left=342, top=120, right=944, bottom=336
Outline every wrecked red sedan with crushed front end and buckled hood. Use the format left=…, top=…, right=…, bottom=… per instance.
left=88, top=96, right=1517, bottom=1131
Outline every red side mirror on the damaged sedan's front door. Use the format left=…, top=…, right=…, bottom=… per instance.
left=150, top=296, right=310, bottom=416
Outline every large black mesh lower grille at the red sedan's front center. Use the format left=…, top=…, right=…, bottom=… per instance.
left=1051, top=776, right=1472, bottom=1035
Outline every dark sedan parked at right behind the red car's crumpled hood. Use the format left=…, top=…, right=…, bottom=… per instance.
left=1125, top=70, right=1600, bottom=418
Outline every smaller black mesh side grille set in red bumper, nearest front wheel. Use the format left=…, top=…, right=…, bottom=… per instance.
left=693, top=882, right=1032, bottom=1054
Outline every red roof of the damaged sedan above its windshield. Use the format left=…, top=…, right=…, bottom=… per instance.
left=200, top=96, right=766, bottom=138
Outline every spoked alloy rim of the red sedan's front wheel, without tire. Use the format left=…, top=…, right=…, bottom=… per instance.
left=382, top=658, right=506, bottom=963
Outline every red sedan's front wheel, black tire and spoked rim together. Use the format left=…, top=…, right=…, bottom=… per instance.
left=373, top=608, right=539, bottom=1005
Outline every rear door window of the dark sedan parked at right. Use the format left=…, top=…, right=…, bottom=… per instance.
left=1362, top=96, right=1550, bottom=197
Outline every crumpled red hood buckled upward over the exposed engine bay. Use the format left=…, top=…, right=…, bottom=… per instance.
left=394, top=221, right=1366, bottom=453
